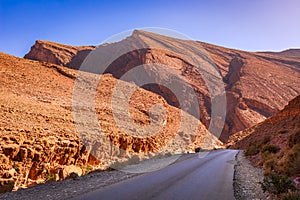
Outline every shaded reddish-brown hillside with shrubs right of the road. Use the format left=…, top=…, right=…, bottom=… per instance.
left=228, top=96, right=300, bottom=177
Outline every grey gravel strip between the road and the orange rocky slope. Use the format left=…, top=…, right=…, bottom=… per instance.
left=0, top=170, right=139, bottom=200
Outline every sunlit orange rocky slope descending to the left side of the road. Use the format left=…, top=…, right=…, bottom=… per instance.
left=0, top=52, right=222, bottom=192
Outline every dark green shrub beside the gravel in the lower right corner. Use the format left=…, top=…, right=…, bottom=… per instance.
left=260, top=174, right=296, bottom=196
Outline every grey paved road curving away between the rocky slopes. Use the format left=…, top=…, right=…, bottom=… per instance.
left=78, top=150, right=238, bottom=200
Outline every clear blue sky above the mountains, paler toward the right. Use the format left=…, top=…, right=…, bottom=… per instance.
left=0, top=0, right=300, bottom=57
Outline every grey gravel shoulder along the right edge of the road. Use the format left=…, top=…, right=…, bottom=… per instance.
left=233, top=151, right=271, bottom=200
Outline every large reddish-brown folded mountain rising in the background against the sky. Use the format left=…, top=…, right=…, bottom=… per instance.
left=25, top=30, right=300, bottom=141
